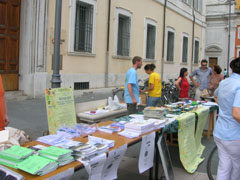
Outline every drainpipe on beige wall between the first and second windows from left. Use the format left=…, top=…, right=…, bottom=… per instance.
left=104, top=0, right=111, bottom=88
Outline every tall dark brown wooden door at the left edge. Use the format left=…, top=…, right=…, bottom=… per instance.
left=0, top=0, right=21, bottom=90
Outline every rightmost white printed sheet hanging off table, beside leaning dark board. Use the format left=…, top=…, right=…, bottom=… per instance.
left=138, top=132, right=156, bottom=173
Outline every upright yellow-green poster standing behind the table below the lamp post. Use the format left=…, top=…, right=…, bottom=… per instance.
left=45, top=88, right=77, bottom=134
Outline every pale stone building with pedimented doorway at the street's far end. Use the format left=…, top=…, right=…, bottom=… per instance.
left=205, top=0, right=240, bottom=69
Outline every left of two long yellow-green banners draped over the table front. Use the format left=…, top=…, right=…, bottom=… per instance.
left=177, top=113, right=203, bottom=173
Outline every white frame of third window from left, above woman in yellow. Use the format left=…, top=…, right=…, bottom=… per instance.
left=143, top=18, right=157, bottom=59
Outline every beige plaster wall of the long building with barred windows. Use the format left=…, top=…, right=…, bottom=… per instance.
left=47, top=0, right=203, bottom=88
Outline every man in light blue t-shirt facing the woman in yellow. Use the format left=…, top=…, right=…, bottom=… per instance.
left=124, top=56, right=142, bottom=114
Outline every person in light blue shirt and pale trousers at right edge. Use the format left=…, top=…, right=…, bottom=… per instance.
left=213, top=57, right=240, bottom=180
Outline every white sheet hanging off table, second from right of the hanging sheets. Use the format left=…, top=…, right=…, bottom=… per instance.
left=102, top=144, right=127, bottom=180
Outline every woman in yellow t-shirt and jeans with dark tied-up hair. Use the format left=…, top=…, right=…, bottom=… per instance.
left=142, top=64, right=162, bottom=107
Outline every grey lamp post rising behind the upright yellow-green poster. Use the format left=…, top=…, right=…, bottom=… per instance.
left=51, top=0, right=62, bottom=88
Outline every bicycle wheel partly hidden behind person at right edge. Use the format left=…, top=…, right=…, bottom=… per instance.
left=207, top=146, right=219, bottom=180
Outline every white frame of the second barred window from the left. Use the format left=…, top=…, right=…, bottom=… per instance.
left=114, top=7, right=132, bottom=57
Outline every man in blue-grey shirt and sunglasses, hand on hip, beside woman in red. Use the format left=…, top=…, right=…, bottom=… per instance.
left=189, top=59, right=212, bottom=100
